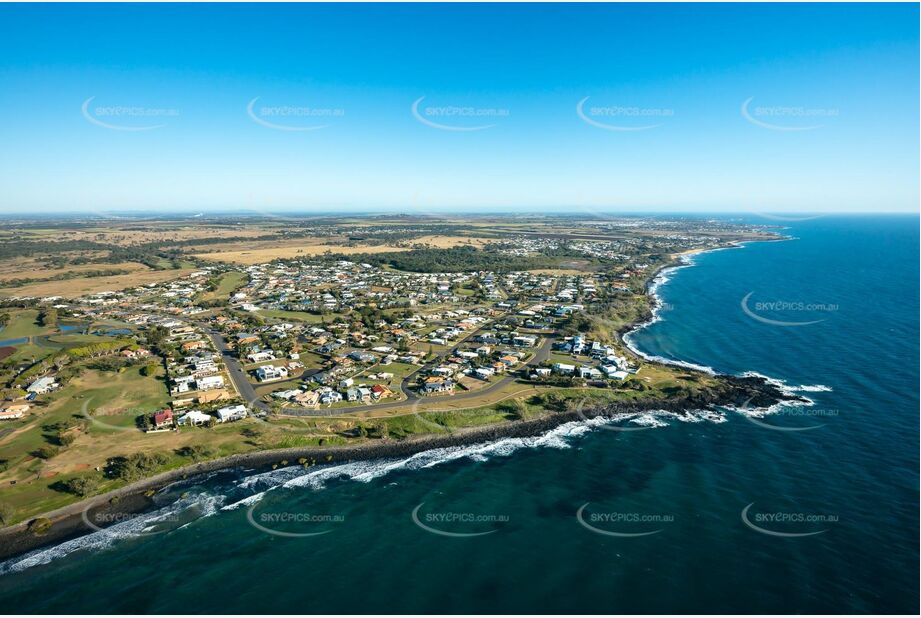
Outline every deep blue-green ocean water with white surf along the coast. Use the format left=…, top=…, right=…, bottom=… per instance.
left=0, top=216, right=919, bottom=613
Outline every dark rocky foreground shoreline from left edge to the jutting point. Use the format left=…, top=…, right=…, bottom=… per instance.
left=0, top=376, right=802, bottom=560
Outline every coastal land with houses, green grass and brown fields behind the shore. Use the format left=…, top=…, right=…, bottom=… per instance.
left=0, top=216, right=776, bottom=525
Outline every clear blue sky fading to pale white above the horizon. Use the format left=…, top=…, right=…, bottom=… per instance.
left=0, top=4, right=919, bottom=213
